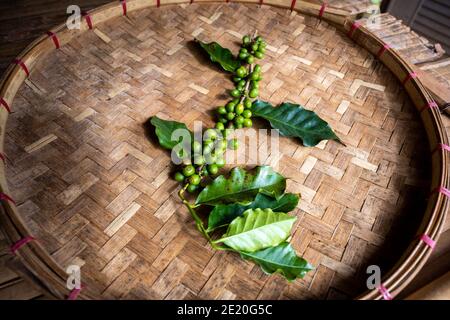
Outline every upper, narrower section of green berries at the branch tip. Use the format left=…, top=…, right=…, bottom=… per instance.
left=216, top=35, right=266, bottom=130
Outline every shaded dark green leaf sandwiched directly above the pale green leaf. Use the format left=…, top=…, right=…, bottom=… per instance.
left=208, top=193, right=299, bottom=232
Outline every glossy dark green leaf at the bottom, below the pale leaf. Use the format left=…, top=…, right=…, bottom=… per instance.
left=241, top=242, right=313, bottom=281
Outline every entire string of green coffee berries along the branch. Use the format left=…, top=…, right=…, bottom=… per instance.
left=175, top=35, right=266, bottom=192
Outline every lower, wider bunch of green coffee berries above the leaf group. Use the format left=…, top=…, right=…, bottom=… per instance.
left=175, top=129, right=238, bottom=192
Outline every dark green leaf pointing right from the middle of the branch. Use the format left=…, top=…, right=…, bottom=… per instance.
left=252, top=100, right=340, bottom=147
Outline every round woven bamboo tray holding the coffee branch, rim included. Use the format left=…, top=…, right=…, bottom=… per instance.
left=0, top=0, right=448, bottom=299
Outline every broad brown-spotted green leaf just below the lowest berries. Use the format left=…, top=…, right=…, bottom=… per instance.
left=195, top=166, right=286, bottom=205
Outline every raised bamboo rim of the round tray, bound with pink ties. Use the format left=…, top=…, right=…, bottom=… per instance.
left=0, top=0, right=449, bottom=300
